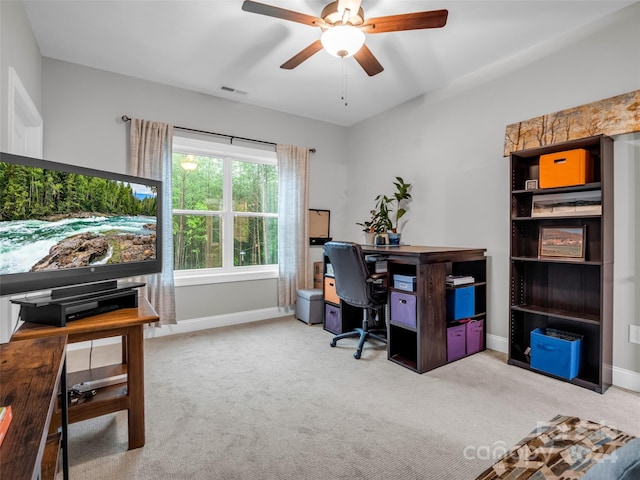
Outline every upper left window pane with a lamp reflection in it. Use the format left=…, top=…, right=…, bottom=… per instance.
left=171, top=153, right=224, bottom=211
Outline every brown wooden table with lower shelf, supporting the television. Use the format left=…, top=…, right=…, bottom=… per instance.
left=11, top=297, right=159, bottom=450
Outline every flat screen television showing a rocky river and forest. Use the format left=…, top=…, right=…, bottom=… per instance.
left=0, top=153, right=162, bottom=295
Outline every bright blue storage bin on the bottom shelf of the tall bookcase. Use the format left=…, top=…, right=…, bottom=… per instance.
left=530, top=328, right=582, bottom=380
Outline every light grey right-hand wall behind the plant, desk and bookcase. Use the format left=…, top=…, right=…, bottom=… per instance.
left=349, top=4, right=640, bottom=378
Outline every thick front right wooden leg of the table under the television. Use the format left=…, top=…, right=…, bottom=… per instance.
left=126, top=325, right=145, bottom=450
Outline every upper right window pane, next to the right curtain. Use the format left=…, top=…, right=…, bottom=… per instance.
left=232, top=160, right=278, bottom=213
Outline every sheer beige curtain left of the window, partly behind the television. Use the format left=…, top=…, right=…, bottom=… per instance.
left=129, top=118, right=176, bottom=325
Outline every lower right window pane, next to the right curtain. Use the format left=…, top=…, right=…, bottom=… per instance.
left=233, top=216, right=278, bottom=266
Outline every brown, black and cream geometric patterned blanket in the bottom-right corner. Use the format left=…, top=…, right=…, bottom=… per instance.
left=476, top=415, right=635, bottom=480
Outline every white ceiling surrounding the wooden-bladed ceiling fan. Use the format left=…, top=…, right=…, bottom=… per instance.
left=24, top=0, right=634, bottom=126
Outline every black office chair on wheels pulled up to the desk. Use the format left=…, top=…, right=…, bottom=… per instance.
left=324, top=242, right=387, bottom=358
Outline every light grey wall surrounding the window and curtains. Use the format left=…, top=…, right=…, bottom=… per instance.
left=42, top=58, right=347, bottom=320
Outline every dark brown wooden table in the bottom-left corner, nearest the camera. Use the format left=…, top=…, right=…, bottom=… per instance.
left=0, top=335, right=69, bottom=480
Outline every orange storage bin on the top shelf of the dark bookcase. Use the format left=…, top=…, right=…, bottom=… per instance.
left=540, top=148, right=593, bottom=188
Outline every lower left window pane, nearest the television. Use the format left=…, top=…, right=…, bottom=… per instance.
left=173, top=214, right=222, bottom=270
